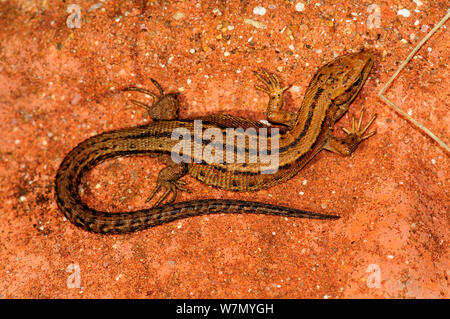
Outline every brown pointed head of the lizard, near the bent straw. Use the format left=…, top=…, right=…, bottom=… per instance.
left=318, top=52, right=374, bottom=105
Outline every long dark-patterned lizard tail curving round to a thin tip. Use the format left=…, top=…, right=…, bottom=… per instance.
left=55, top=125, right=339, bottom=234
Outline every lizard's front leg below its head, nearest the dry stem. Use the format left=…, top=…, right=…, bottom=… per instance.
left=323, top=109, right=377, bottom=156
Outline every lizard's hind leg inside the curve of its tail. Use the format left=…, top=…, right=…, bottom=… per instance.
left=146, top=158, right=191, bottom=207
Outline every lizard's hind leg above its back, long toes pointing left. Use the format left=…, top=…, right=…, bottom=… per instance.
left=122, top=79, right=180, bottom=121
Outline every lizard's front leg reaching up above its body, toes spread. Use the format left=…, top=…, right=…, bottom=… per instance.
left=255, top=69, right=297, bottom=127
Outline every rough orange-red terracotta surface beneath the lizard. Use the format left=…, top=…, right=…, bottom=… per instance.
left=0, top=0, right=450, bottom=298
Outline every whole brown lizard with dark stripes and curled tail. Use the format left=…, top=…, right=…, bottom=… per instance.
left=55, top=51, right=376, bottom=234
